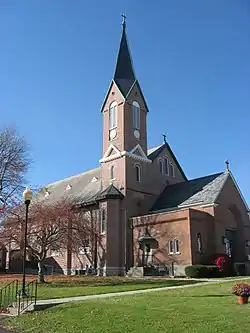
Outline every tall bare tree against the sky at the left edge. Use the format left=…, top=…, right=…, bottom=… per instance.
left=0, top=127, right=31, bottom=207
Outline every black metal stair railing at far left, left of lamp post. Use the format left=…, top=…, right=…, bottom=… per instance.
left=0, top=280, right=18, bottom=312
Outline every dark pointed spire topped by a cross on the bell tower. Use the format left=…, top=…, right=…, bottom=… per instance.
left=114, top=14, right=136, bottom=97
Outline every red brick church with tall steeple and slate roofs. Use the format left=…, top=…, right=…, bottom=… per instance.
left=4, top=22, right=250, bottom=275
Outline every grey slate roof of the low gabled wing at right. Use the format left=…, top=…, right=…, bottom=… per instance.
left=151, top=172, right=229, bottom=212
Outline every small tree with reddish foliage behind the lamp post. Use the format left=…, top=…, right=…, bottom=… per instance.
left=0, top=201, right=71, bottom=283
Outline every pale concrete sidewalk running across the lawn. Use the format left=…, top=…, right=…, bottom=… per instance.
left=29, top=277, right=250, bottom=312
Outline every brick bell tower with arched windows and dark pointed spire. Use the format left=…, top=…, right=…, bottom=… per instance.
left=100, top=15, right=151, bottom=194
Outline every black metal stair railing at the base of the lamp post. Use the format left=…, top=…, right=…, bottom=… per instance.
left=18, top=280, right=37, bottom=315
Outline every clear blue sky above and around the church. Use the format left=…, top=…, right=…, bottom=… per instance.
left=0, top=0, right=250, bottom=203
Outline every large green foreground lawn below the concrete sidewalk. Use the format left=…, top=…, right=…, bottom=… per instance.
left=4, top=281, right=250, bottom=333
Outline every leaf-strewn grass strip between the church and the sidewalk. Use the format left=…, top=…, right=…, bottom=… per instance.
left=2, top=276, right=197, bottom=299
